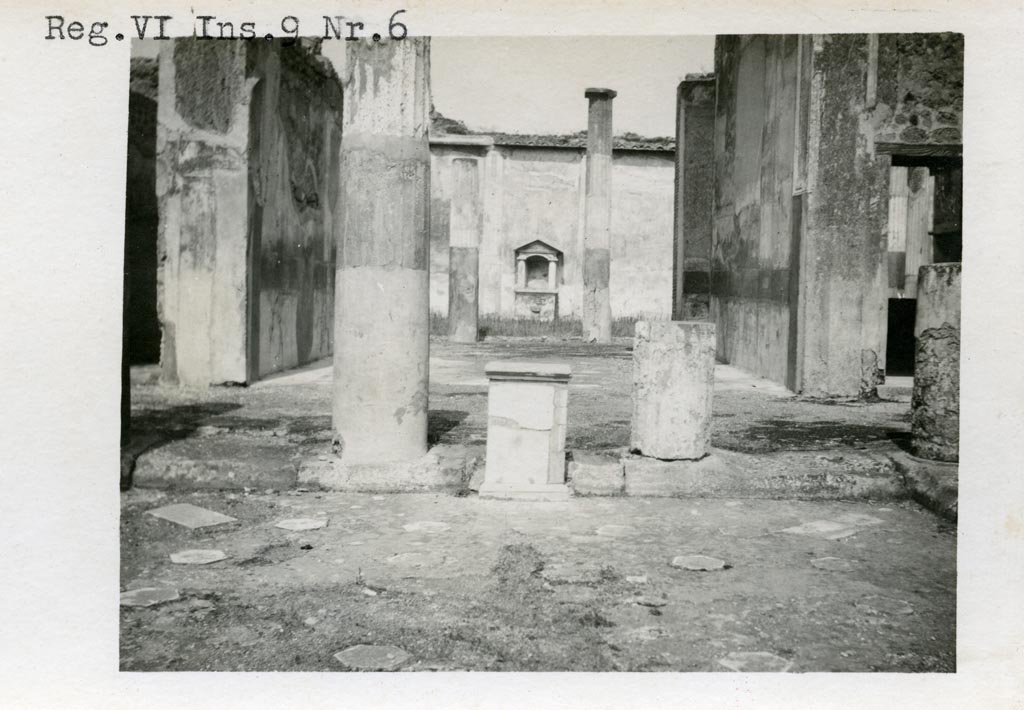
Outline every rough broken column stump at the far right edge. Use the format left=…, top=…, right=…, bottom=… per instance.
left=910, top=262, right=961, bottom=461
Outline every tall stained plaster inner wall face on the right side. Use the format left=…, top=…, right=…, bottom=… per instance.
left=711, top=35, right=798, bottom=382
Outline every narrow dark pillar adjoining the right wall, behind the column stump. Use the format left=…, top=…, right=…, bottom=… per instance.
left=672, top=74, right=715, bottom=321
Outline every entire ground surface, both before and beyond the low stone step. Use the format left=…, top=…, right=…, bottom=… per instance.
left=121, top=339, right=956, bottom=672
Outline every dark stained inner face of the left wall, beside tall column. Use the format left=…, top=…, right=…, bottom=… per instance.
left=249, top=47, right=342, bottom=377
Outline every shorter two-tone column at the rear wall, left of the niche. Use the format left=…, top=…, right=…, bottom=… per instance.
left=449, top=158, right=482, bottom=342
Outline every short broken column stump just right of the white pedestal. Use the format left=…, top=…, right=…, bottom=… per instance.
left=630, top=321, right=715, bottom=459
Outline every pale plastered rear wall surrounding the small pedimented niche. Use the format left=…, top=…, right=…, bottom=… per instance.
left=430, top=144, right=675, bottom=318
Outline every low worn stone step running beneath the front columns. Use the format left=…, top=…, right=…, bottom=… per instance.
left=125, top=432, right=957, bottom=510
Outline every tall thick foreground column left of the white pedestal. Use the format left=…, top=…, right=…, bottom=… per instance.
left=334, top=38, right=430, bottom=465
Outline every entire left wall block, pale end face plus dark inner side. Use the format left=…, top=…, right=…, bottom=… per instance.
left=157, top=38, right=341, bottom=386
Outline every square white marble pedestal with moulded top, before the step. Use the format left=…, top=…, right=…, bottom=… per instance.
left=480, top=361, right=571, bottom=500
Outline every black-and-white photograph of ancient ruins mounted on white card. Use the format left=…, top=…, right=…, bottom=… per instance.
left=120, top=33, right=964, bottom=672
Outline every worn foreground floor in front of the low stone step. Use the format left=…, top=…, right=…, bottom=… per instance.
left=121, top=490, right=955, bottom=672
